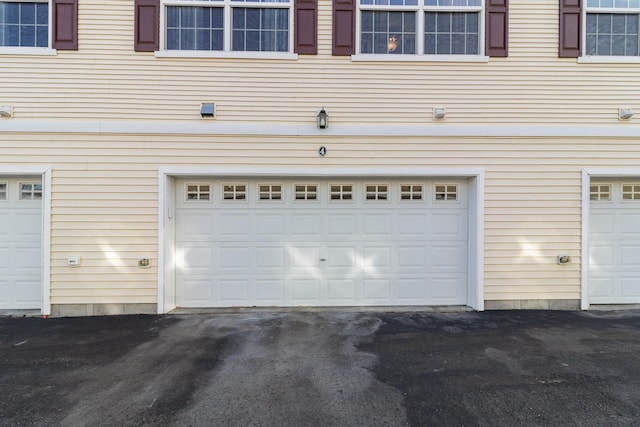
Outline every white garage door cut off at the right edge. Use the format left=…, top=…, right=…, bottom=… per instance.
left=589, top=181, right=640, bottom=304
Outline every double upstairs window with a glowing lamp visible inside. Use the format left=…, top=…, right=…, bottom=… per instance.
left=359, top=0, right=484, bottom=55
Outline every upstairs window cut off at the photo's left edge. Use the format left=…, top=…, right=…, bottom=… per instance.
left=0, top=0, right=49, bottom=47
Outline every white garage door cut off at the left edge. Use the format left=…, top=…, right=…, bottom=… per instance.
left=0, top=177, right=42, bottom=309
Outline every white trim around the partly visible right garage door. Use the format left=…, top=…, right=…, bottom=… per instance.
left=580, top=168, right=640, bottom=310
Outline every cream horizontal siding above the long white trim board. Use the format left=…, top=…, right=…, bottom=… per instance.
left=0, top=0, right=640, bottom=126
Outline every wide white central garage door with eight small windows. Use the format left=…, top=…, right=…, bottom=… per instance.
left=176, top=179, right=468, bottom=307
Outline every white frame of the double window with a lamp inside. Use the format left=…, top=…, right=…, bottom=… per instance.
left=352, top=0, right=489, bottom=62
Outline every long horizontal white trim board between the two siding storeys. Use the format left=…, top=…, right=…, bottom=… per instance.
left=0, top=120, right=640, bottom=138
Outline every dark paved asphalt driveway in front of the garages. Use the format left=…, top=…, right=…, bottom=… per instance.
left=0, top=311, right=640, bottom=426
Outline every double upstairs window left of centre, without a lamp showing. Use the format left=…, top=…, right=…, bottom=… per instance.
left=163, top=0, right=293, bottom=52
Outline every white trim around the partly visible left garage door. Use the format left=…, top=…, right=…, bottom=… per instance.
left=0, top=165, right=51, bottom=316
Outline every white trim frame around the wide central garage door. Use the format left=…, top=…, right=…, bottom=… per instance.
left=158, top=167, right=484, bottom=314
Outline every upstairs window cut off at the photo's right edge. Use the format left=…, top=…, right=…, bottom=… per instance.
left=585, top=0, right=640, bottom=56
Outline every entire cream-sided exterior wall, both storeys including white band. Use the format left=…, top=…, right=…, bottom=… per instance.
left=0, top=0, right=640, bottom=314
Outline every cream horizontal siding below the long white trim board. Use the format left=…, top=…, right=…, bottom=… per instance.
left=0, top=133, right=640, bottom=304
